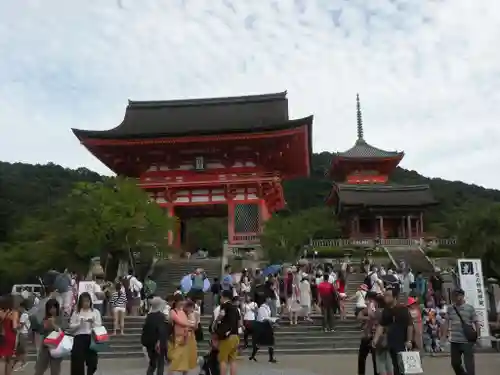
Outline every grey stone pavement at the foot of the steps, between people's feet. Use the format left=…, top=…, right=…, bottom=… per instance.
left=12, top=353, right=500, bottom=375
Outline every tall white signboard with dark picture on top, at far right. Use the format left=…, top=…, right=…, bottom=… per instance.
left=457, top=259, right=491, bottom=347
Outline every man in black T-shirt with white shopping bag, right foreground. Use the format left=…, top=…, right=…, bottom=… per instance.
left=373, top=289, right=413, bottom=375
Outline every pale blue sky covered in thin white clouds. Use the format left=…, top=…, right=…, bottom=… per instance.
left=0, top=0, right=500, bottom=188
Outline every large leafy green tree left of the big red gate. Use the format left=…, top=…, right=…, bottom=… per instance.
left=0, top=178, right=173, bottom=282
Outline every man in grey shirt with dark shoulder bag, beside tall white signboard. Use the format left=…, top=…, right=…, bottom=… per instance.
left=448, top=289, right=481, bottom=375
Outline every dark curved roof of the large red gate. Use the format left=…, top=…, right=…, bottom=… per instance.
left=73, top=92, right=312, bottom=140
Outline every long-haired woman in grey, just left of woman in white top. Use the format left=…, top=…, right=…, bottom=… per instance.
left=35, top=298, right=63, bottom=375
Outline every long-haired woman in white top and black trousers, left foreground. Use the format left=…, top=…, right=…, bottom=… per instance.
left=69, top=292, right=102, bottom=375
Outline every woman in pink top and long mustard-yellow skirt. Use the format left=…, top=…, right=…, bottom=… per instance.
left=168, top=295, right=194, bottom=374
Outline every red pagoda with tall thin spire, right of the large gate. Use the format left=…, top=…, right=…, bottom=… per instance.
left=327, top=95, right=436, bottom=239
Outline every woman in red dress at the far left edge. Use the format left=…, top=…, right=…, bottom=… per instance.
left=0, top=295, right=19, bottom=375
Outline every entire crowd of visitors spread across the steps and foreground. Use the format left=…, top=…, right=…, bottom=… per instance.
left=0, top=262, right=486, bottom=375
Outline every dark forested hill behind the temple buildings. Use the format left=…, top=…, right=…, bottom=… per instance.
left=0, top=152, right=500, bottom=241
